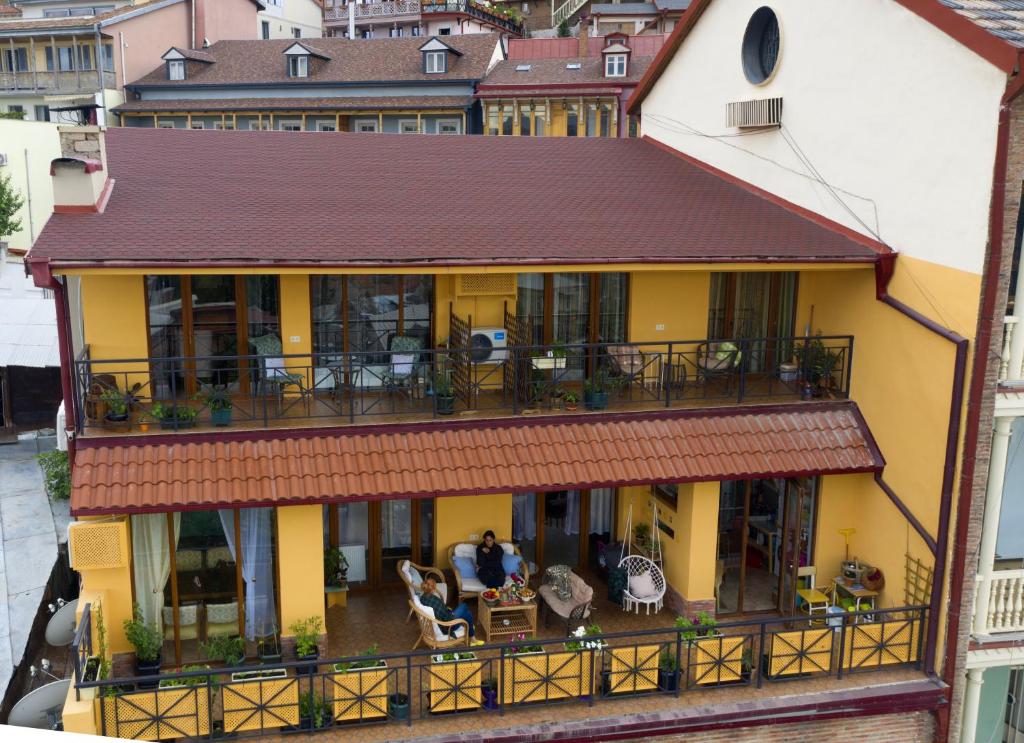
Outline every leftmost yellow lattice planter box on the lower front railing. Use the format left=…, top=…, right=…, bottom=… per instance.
left=97, top=685, right=210, bottom=740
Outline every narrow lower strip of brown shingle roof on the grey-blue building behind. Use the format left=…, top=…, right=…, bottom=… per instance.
left=112, top=95, right=473, bottom=114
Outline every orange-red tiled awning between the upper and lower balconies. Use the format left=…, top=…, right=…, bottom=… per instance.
left=72, top=402, right=885, bottom=516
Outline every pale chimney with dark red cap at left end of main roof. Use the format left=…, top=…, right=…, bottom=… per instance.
left=50, top=127, right=114, bottom=214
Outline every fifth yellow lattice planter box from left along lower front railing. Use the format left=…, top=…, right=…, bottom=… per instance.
left=499, top=650, right=598, bottom=704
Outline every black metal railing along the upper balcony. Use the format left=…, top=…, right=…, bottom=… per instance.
left=75, top=336, right=853, bottom=432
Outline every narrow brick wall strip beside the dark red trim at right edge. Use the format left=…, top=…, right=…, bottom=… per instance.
left=948, top=93, right=1024, bottom=741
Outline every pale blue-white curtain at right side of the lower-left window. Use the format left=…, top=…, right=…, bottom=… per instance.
left=219, top=509, right=278, bottom=640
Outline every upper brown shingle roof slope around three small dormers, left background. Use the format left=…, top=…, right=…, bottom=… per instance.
left=131, top=34, right=499, bottom=88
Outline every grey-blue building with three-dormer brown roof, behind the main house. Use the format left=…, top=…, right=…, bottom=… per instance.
left=114, top=34, right=504, bottom=134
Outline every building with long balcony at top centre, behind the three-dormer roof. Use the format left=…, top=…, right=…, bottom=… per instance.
left=324, top=0, right=523, bottom=39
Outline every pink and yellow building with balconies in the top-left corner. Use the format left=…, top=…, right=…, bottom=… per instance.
left=0, top=0, right=262, bottom=124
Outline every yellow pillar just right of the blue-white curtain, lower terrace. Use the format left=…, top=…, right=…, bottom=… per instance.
left=278, top=504, right=327, bottom=637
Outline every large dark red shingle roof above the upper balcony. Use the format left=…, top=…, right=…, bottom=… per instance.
left=31, top=127, right=889, bottom=267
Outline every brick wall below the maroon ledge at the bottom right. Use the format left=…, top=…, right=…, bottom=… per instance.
left=634, top=712, right=935, bottom=743
